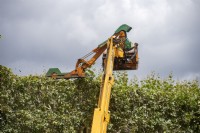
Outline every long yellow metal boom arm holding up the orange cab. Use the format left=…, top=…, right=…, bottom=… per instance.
left=91, top=37, right=116, bottom=133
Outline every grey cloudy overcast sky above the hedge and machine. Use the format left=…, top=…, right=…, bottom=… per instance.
left=0, top=0, right=200, bottom=80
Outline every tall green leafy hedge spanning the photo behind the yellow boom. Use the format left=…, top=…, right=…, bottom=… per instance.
left=0, top=66, right=200, bottom=133
